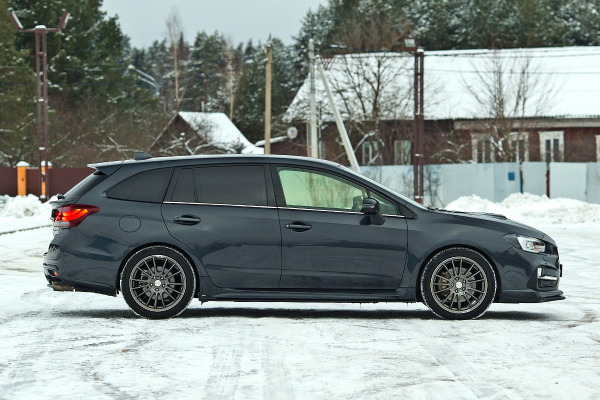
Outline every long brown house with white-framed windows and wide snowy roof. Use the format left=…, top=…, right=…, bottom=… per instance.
left=282, top=47, right=600, bottom=165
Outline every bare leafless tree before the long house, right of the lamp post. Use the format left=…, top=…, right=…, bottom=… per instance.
left=462, top=50, right=557, bottom=162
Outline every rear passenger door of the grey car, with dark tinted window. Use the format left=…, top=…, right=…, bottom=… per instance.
left=162, top=164, right=281, bottom=289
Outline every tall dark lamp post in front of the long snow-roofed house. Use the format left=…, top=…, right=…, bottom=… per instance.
left=404, top=36, right=425, bottom=204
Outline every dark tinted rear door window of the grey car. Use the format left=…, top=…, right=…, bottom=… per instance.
left=194, top=165, right=267, bottom=206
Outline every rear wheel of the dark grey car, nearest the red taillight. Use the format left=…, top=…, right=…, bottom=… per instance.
left=121, top=246, right=196, bottom=319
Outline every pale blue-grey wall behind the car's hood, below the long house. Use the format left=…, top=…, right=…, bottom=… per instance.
left=361, top=162, right=600, bottom=207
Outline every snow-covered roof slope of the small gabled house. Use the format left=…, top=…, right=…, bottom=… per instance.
left=179, top=111, right=264, bottom=154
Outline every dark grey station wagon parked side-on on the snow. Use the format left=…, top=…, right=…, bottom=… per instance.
left=44, top=152, right=564, bottom=319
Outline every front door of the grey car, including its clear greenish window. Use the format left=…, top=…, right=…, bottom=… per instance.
left=273, top=167, right=407, bottom=289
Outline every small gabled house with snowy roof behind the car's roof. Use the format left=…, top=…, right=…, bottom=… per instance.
left=150, top=111, right=264, bottom=155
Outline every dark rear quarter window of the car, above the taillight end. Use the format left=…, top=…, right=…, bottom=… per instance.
left=106, top=168, right=173, bottom=203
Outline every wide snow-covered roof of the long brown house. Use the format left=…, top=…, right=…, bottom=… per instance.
left=285, top=46, right=600, bottom=121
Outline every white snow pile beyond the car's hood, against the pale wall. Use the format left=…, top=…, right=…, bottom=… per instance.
left=445, top=193, right=600, bottom=225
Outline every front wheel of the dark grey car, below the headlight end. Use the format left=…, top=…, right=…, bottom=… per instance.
left=421, top=247, right=497, bottom=320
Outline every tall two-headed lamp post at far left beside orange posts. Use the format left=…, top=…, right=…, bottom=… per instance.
left=9, top=11, right=69, bottom=200
